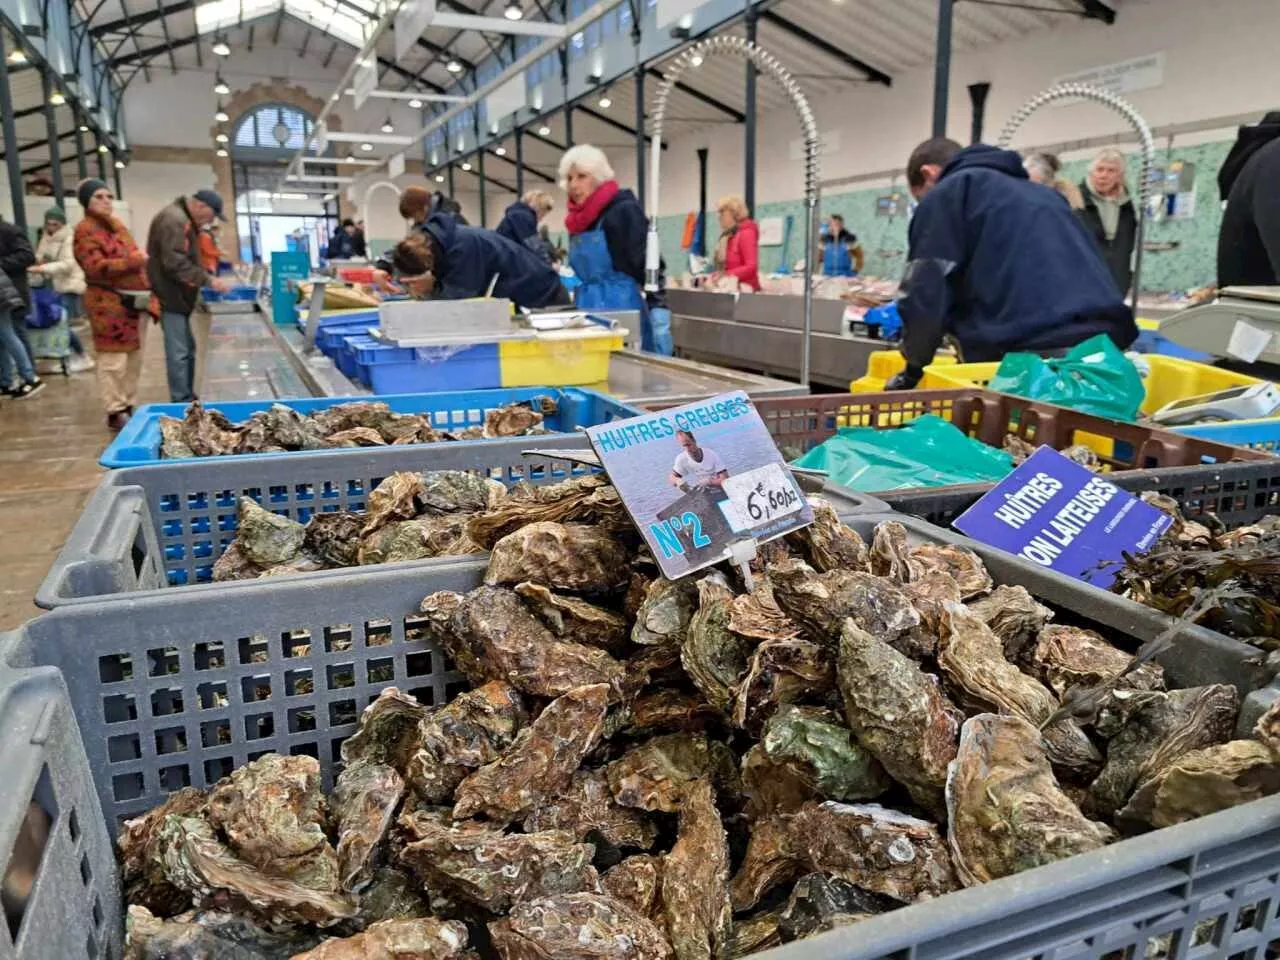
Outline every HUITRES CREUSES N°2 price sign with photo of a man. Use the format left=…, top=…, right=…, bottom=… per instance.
left=586, top=392, right=813, bottom=579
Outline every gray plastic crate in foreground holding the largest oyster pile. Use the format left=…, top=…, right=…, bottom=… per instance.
left=0, top=516, right=1280, bottom=960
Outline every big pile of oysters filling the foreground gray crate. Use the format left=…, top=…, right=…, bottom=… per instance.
left=120, top=506, right=1280, bottom=960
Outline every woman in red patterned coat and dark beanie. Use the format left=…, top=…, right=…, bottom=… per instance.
left=74, top=179, right=160, bottom=430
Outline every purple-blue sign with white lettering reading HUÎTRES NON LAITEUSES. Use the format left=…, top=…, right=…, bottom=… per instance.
left=955, top=447, right=1174, bottom=588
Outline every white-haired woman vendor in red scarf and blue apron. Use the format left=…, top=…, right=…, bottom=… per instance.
left=559, top=145, right=673, bottom=356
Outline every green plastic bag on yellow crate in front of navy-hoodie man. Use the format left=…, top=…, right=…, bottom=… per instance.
left=987, top=333, right=1147, bottom=420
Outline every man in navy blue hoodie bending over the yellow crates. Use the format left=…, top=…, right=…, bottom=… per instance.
left=887, top=137, right=1138, bottom=390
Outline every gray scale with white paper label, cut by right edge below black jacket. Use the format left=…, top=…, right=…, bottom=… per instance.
left=1160, top=287, right=1280, bottom=364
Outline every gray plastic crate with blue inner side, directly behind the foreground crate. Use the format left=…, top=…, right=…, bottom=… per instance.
left=36, top=434, right=888, bottom=609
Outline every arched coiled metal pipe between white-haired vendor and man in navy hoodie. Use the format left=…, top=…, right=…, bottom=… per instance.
left=644, top=37, right=818, bottom=384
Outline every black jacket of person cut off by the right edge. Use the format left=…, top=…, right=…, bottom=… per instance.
left=1217, top=140, right=1280, bottom=287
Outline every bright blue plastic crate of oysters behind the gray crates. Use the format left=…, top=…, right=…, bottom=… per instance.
left=99, top=387, right=641, bottom=468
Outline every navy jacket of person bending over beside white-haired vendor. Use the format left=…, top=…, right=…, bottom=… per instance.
left=421, top=211, right=567, bottom=307
